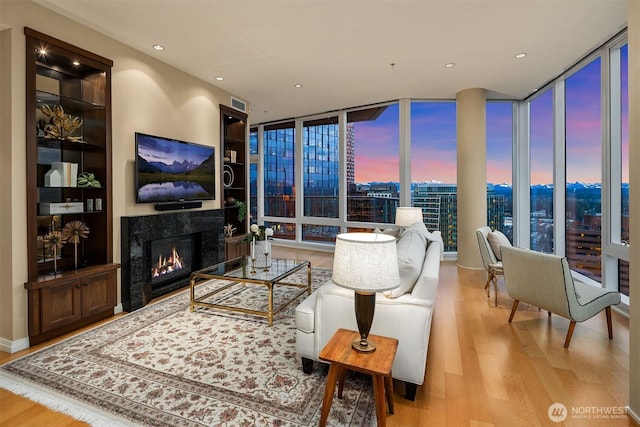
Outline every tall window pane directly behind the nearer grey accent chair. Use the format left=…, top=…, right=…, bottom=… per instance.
left=565, top=57, right=602, bottom=281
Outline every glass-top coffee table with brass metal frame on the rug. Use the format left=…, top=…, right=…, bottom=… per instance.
left=190, top=257, right=311, bottom=326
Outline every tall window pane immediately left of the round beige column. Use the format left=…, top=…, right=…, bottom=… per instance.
left=411, top=101, right=458, bottom=252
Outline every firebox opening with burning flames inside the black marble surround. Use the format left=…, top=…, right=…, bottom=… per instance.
left=151, top=235, right=193, bottom=289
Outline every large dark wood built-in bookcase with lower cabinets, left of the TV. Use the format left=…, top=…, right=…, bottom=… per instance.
left=24, top=28, right=118, bottom=344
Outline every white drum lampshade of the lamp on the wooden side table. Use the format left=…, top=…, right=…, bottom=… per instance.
left=332, top=233, right=400, bottom=292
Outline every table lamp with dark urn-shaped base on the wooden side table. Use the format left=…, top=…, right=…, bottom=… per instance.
left=332, top=233, right=400, bottom=353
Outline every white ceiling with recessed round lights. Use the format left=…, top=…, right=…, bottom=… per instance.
left=37, top=0, right=627, bottom=123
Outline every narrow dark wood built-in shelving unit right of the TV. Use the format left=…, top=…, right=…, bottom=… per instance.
left=220, top=105, right=249, bottom=259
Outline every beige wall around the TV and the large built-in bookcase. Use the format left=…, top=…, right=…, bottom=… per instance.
left=0, top=0, right=240, bottom=351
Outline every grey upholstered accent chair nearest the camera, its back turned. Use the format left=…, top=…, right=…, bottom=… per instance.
left=502, top=247, right=620, bottom=348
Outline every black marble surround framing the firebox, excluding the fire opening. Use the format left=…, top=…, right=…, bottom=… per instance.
left=120, top=209, right=224, bottom=312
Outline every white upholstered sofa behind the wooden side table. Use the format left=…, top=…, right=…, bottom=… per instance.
left=296, top=223, right=444, bottom=400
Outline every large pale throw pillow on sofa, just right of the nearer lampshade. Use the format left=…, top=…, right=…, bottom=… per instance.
left=384, top=229, right=427, bottom=298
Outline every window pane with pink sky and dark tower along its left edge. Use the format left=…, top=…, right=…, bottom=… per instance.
left=345, top=103, right=400, bottom=223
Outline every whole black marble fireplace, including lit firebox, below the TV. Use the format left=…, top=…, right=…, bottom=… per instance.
left=120, top=209, right=224, bottom=312
